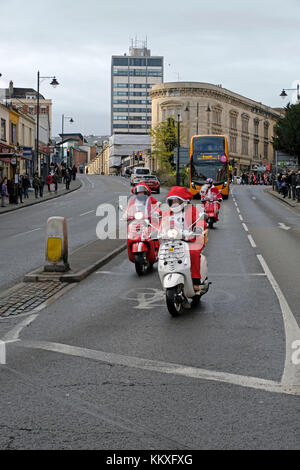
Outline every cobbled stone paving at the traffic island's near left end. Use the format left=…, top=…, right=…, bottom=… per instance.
left=0, top=281, right=66, bottom=317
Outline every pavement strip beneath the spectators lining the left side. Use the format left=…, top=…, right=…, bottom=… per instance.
left=0, top=178, right=82, bottom=214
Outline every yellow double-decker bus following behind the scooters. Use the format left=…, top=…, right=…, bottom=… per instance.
left=189, top=135, right=230, bottom=199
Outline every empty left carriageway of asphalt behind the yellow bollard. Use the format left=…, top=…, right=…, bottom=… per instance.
left=0, top=175, right=135, bottom=290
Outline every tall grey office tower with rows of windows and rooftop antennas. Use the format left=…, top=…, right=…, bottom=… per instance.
left=111, top=40, right=163, bottom=134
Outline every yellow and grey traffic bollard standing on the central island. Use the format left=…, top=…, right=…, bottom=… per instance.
left=44, top=217, right=70, bottom=272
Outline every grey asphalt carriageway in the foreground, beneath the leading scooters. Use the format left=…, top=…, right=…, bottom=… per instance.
left=0, top=177, right=300, bottom=450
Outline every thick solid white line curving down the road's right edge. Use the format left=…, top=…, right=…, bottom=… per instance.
left=257, top=255, right=300, bottom=386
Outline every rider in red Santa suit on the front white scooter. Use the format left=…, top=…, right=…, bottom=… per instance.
left=160, top=186, right=207, bottom=291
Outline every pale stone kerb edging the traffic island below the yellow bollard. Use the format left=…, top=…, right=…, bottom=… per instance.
left=24, top=242, right=127, bottom=283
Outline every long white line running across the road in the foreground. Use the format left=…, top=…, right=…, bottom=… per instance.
left=19, top=341, right=300, bottom=395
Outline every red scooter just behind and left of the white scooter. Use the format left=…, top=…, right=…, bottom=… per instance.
left=127, top=212, right=159, bottom=276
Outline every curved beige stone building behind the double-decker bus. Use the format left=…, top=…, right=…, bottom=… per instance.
left=150, top=82, right=283, bottom=175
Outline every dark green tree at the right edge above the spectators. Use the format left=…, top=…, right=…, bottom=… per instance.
left=272, top=103, right=300, bottom=166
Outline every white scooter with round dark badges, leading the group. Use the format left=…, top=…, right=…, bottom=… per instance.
left=158, top=214, right=211, bottom=317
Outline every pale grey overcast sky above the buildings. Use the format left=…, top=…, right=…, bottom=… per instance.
left=0, top=0, right=300, bottom=135
